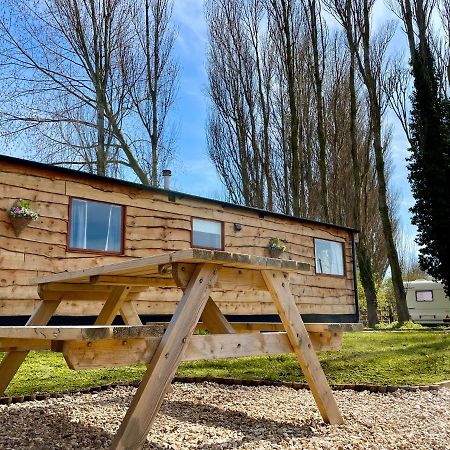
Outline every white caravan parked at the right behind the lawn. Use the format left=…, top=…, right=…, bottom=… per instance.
left=404, top=280, right=450, bottom=325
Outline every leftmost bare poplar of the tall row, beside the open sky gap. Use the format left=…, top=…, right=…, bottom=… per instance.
left=207, top=0, right=273, bottom=208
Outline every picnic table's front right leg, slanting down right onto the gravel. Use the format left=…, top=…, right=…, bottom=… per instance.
left=261, top=270, right=344, bottom=424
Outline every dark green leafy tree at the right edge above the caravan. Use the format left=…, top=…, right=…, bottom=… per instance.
left=408, top=41, right=450, bottom=296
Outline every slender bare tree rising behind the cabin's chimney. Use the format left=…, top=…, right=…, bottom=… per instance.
left=125, top=0, right=178, bottom=186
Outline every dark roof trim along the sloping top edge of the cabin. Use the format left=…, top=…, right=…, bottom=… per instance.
left=0, top=155, right=358, bottom=232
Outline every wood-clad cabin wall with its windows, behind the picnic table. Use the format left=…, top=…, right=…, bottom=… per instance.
left=0, top=156, right=359, bottom=325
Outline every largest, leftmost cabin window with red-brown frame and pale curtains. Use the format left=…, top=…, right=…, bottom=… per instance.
left=69, top=198, right=124, bottom=253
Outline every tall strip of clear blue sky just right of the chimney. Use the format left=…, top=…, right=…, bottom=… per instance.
left=171, top=0, right=223, bottom=197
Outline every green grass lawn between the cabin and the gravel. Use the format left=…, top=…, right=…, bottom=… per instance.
left=0, top=331, right=450, bottom=395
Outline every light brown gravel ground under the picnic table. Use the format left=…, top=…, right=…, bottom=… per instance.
left=0, top=383, right=450, bottom=450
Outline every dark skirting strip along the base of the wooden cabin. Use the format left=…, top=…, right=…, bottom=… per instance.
left=0, top=314, right=358, bottom=326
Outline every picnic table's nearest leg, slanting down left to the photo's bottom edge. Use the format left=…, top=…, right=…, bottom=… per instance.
left=110, top=264, right=219, bottom=449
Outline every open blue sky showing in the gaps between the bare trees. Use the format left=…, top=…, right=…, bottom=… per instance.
left=171, top=0, right=416, bottom=240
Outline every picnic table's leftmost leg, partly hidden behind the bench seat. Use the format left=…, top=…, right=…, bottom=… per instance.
left=0, top=300, right=60, bottom=395
